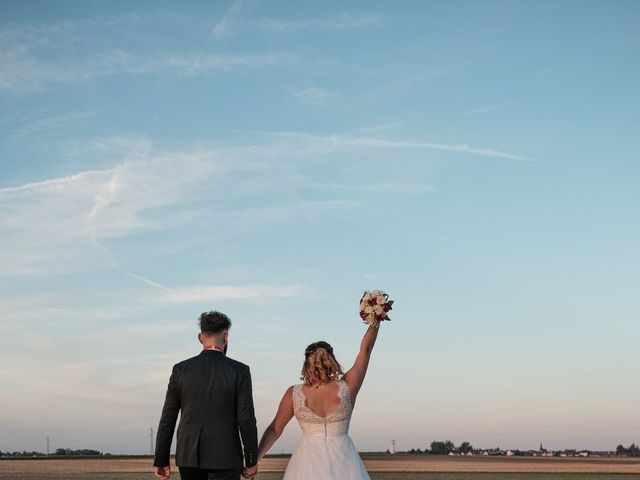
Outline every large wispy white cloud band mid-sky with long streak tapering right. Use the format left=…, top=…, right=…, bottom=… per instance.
left=0, top=132, right=527, bottom=280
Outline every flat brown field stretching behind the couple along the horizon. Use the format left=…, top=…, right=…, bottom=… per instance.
left=0, top=454, right=640, bottom=480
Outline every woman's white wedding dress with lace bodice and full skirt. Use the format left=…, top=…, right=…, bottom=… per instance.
left=283, top=381, right=370, bottom=480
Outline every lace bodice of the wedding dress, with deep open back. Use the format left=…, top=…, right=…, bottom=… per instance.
left=293, top=380, right=353, bottom=434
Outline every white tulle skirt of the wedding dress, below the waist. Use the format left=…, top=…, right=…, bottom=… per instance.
left=283, top=434, right=370, bottom=480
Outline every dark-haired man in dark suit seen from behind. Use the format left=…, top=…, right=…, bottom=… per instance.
left=153, top=311, right=258, bottom=480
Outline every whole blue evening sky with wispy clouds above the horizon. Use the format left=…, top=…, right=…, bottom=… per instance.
left=0, top=0, right=640, bottom=454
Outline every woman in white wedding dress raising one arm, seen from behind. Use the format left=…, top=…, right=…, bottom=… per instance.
left=250, top=325, right=379, bottom=480
